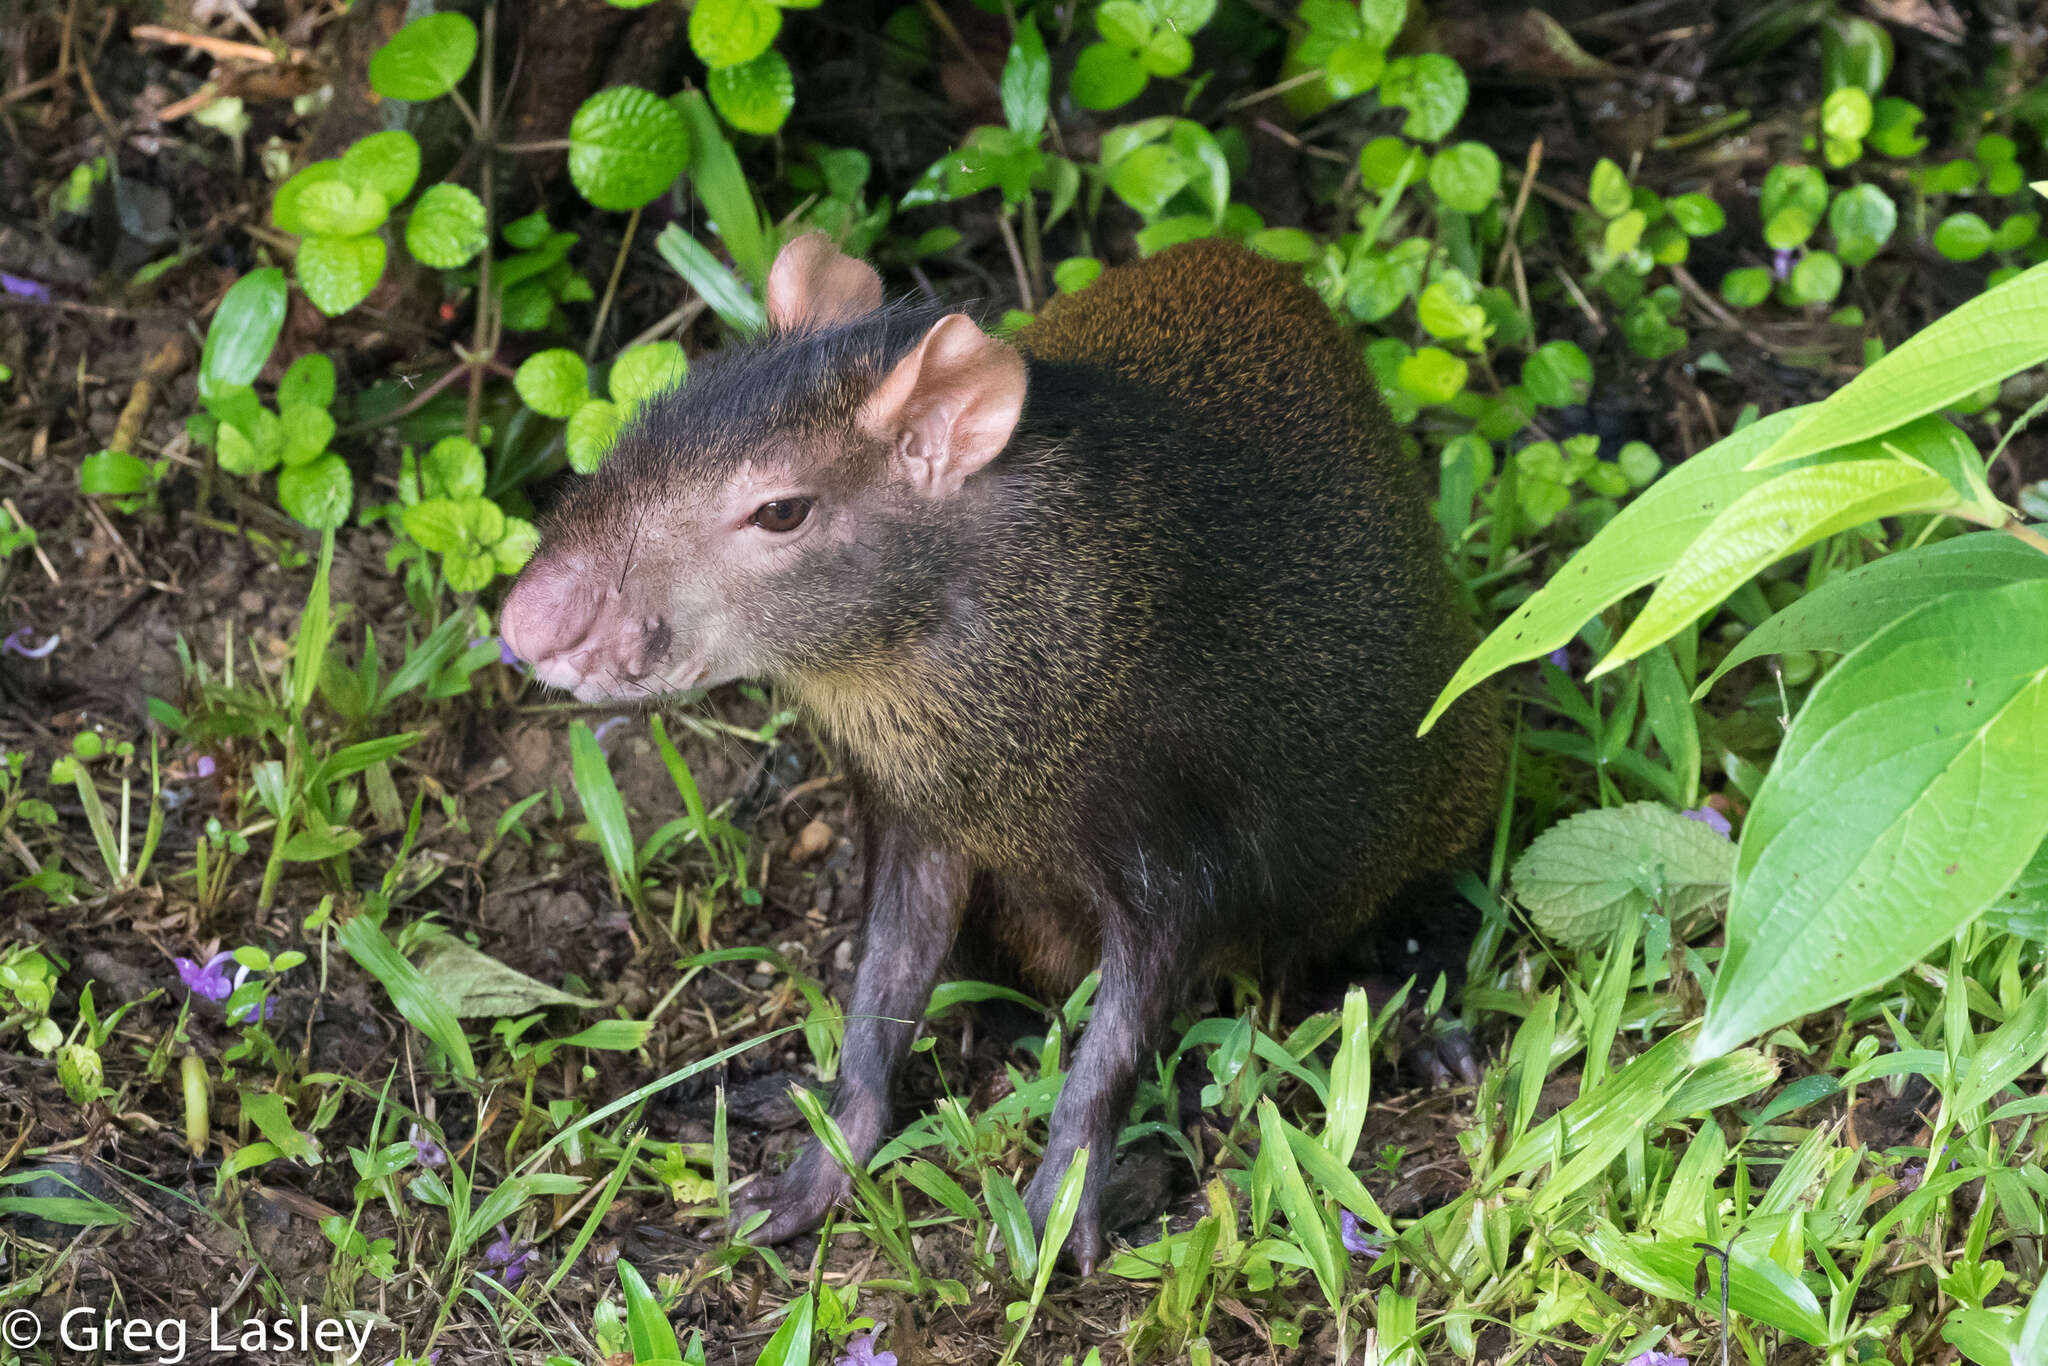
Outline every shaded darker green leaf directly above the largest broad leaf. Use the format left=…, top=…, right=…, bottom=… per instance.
left=1694, top=530, right=2048, bottom=700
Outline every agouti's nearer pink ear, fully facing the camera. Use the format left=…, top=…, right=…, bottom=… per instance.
left=860, top=313, right=1024, bottom=498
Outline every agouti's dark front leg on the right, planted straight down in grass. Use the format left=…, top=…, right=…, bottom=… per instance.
left=1024, top=915, right=1184, bottom=1276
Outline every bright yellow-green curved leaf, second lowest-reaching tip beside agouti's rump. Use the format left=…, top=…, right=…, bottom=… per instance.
left=1567, top=459, right=1962, bottom=680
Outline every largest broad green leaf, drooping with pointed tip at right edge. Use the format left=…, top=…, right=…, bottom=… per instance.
left=1696, top=580, right=2048, bottom=1057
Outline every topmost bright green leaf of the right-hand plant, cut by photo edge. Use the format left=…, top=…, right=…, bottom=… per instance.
left=1755, top=264, right=2048, bottom=469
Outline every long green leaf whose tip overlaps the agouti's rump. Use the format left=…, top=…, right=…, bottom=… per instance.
left=1421, top=408, right=1804, bottom=731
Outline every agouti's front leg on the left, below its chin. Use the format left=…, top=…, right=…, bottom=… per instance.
left=733, top=825, right=969, bottom=1243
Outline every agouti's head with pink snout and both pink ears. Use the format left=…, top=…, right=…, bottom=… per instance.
left=500, top=233, right=1024, bottom=700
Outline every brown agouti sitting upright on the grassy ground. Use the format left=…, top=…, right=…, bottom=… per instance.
left=502, top=236, right=1503, bottom=1272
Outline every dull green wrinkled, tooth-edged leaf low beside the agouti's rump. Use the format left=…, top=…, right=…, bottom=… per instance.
left=1511, top=801, right=1735, bottom=948
